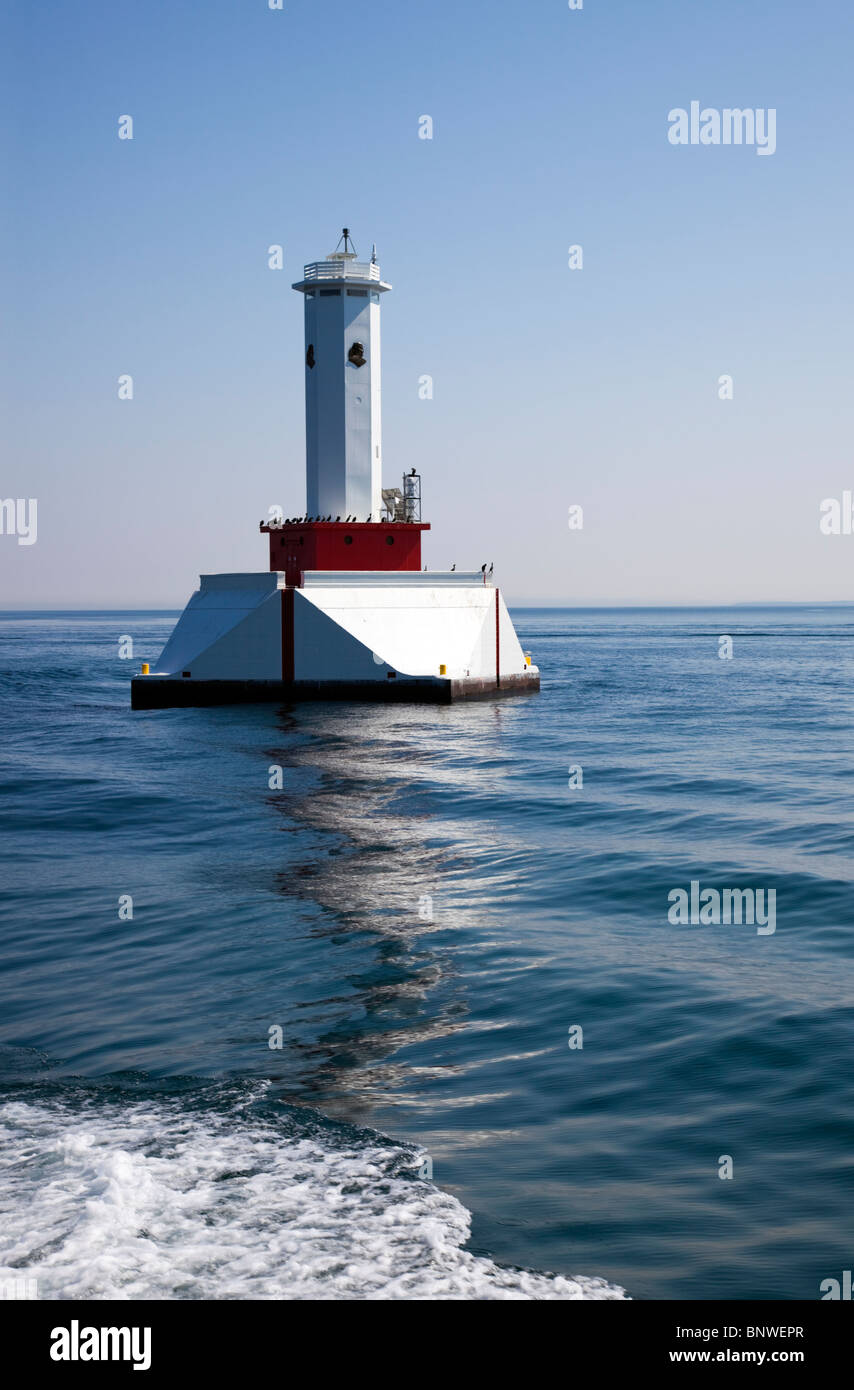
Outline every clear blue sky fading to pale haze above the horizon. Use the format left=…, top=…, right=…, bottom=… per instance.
left=0, top=0, right=854, bottom=609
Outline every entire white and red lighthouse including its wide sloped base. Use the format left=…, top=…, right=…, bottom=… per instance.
left=131, top=228, right=540, bottom=709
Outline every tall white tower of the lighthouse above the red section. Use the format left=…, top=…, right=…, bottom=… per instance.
left=293, top=227, right=391, bottom=521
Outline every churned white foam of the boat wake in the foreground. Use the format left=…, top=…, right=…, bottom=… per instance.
left=0, top=1097, right=626, bottom=1300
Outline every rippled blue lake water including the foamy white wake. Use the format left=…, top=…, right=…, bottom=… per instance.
left=0, top=606, right=854, bottom=1298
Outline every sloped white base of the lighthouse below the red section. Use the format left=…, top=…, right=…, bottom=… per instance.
left=132, top=571, right=540, bottom=708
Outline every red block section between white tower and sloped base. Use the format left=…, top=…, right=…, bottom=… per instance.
left=261, top=521, right=430, bottom=587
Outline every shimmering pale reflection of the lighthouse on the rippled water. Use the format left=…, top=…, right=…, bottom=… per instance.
left=261, top=702, right=528, bottom=1123
